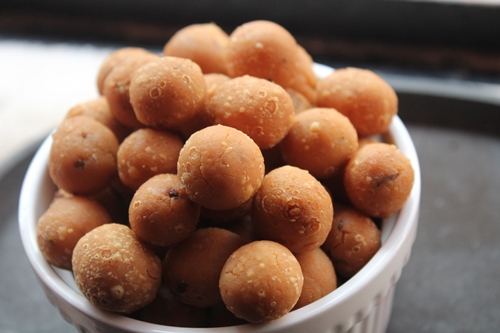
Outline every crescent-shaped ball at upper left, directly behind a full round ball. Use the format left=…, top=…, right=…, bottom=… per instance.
left=103, top=53, right=159, bottom=129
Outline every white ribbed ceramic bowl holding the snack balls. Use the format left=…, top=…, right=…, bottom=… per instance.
left=19, top=64, right=421, bottom=333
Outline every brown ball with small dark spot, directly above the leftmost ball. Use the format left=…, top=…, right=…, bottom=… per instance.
left=49, top=116, right=118, bottom=195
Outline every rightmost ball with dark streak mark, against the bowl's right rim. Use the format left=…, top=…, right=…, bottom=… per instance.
left=344, top=142, right=414, bottom=218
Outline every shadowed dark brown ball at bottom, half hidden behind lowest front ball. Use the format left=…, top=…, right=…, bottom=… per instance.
left=163, top=228, right=244, bottom=307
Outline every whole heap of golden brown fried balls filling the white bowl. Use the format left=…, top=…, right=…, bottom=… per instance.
left=37, top=21, right=414, bottom=327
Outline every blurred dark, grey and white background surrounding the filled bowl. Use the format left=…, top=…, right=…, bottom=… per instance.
left=0, top=0, right=500, bottom=332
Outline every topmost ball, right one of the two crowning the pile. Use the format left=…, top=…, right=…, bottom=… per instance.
left=226, top=21, right=316, bottom=101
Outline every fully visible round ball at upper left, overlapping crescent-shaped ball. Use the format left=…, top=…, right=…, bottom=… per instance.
left=130, top=56, right=207, bottom=129
